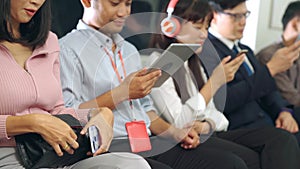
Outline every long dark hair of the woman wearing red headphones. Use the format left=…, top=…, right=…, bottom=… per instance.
left=150, top=0, right=212, bottom=93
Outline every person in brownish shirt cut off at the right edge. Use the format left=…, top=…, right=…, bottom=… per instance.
left=256, top=1, right=300, bottom=107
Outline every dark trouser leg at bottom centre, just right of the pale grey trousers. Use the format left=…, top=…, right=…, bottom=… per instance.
left=153, top=145, right=247, bottom=169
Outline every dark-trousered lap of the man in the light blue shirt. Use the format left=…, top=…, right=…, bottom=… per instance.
left=110, top=137, right=259, bottom=169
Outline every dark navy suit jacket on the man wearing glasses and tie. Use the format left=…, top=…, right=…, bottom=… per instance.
left=200, top=34, right=286, bottom=129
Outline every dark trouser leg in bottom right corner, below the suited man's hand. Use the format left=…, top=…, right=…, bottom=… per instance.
left=217, top=127, right=300, bottom=169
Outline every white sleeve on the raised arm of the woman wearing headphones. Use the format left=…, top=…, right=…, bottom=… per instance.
left=151, top=78, right=206, bottom=128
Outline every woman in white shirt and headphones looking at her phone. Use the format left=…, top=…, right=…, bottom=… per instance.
left=151, top=0, right=299, bottom=169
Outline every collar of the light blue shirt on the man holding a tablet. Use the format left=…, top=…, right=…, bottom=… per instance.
left=76, top=20, right=124, bottom=49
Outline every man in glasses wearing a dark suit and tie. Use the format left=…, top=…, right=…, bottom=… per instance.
left=204, top=0, right=300, bottom=143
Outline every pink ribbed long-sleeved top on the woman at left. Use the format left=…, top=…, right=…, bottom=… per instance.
left=0, top=32, right=86, bottom=147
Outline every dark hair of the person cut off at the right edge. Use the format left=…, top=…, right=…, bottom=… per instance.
left=281, top=1, right=300, bottom=30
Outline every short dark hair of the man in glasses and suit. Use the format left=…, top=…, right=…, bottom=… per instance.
left=209, top=0, right=246, bottom=11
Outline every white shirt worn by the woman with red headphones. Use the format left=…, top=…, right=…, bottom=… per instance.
left=150, top=53, right=229, bottom=131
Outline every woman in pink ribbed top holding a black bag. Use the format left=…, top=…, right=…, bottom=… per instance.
left=0, top=0, right=150, bottom=168
